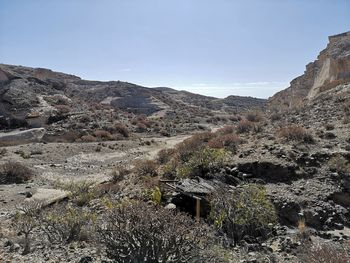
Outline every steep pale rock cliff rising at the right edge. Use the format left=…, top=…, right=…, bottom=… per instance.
left=269, top=32, right=350, bottom=109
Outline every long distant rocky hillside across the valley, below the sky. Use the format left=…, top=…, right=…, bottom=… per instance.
left=0, top=64, right=265, bottom=134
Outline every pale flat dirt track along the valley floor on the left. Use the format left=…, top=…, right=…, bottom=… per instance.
left=0, top=135, right=190, bottom=219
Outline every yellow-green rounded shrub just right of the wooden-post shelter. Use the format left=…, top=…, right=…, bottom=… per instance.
left=210, top=184, right=277, bottom=244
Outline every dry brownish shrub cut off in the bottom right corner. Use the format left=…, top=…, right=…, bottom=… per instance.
left=304, top=243, right=350, bottom=263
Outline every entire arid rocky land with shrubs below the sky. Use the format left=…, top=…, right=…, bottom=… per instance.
left=0, top=32, right=350, bottom=263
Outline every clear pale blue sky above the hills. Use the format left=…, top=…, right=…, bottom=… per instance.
left=0, top=0, right=350, bottom=97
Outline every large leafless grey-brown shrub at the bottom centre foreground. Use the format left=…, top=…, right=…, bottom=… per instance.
left=97, top=202, right=205, bottom=263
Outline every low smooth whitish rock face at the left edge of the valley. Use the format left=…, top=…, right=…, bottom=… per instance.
left=0, top=128, right=46, bottom=144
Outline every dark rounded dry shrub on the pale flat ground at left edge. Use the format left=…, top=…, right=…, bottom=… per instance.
left=0, top=162, right=33, bottom=184
